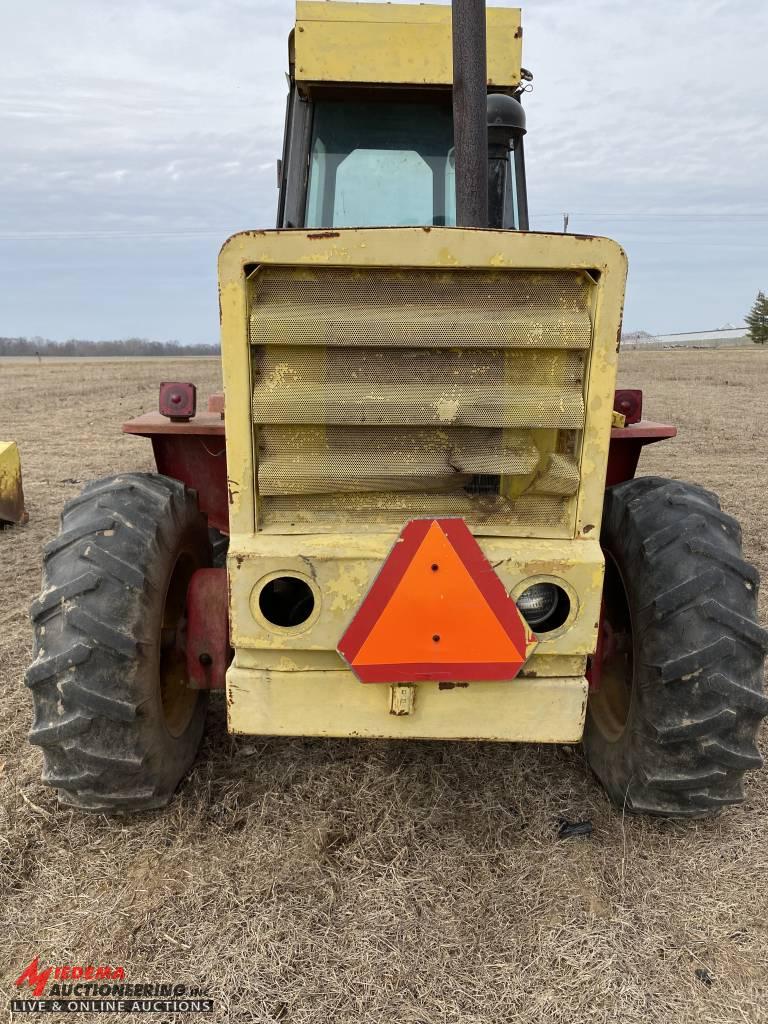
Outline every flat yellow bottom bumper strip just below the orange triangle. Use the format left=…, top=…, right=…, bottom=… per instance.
left=226, top=665, right=588, bottom=743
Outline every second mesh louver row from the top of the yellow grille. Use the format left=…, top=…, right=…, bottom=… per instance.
left=253, top=345, right=585, bottom=429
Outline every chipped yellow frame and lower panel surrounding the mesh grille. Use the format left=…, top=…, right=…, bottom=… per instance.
left=219, top=226, right=626, bottom=741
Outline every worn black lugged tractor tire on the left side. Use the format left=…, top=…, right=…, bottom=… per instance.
left=26, top=473, right=211, bottom=812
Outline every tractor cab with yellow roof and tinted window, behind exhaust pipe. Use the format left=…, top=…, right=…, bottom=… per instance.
left=278, top=0, right=527, bottom=229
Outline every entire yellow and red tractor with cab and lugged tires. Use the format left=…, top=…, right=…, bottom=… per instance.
left=27, top=0, right=768, bottom=816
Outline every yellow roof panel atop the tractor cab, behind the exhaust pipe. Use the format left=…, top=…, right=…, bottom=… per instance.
left=294, top=0, right=522, bottom=88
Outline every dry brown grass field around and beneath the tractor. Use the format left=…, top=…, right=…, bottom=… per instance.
left=0, top=350, right=768, bottom=1024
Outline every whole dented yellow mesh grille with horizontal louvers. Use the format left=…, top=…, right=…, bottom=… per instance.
left=250, top=267, right=595, bottom=536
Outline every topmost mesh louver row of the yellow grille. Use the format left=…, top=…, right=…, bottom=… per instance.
left=251, top=267, right=592, bottom=348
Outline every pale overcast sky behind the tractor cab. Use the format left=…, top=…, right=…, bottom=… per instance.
left=0, top=0, right=768, bottom=342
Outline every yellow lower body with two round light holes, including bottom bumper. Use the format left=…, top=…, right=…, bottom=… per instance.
left=226, top=531, right=603, bottom=742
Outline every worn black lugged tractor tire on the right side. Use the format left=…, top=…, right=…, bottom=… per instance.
left=584, top=477, right=768, bottom=817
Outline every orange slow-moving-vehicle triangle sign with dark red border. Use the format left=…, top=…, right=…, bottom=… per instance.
left=338, top=519, right=537, bottom=683
